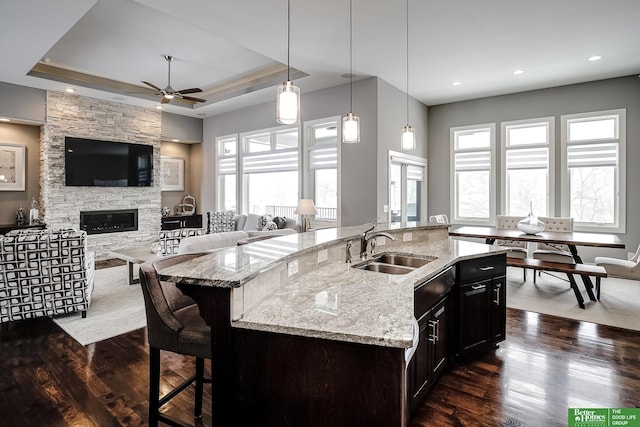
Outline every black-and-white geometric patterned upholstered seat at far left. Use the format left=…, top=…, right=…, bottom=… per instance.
left=0, top=229, right=94, bottom=323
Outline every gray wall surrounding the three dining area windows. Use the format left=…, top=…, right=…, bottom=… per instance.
left=429, top=75, right=640, bottom=261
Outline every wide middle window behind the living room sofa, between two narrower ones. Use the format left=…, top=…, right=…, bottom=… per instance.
left=240, top=127, right=299, bottom=218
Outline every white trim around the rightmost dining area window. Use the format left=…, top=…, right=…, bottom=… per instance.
left=560, top=108, right=627, bottom=233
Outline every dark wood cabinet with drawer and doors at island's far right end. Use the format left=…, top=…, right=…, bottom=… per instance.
left=456, top=255, right=507, bottom=358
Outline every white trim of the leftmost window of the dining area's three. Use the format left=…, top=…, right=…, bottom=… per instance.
left=449, top=123, right=497, bottom=225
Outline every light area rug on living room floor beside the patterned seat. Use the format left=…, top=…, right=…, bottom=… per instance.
left=53, top=265, right=147, bottom=345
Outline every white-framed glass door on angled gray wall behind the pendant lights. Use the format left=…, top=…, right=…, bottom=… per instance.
left=389, top=151, right=427, bottom=222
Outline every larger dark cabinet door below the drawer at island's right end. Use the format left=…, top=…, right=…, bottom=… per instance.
left=458, top=279, right=491, bottom=357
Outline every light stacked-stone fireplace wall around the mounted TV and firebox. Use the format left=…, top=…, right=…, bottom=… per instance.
left=40, top=91, right=161, bottom=260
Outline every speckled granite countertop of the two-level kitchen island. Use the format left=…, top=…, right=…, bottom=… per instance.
left=159, top=224, right=508, bottom=348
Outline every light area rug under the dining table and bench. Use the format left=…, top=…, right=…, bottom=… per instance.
left=507, top=267, right=640, bottom=331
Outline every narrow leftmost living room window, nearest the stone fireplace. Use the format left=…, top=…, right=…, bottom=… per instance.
left=216, top=135, right=238, bottom=211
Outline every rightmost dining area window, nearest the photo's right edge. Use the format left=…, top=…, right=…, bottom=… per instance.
left=561, top=109, right=626, bottom=232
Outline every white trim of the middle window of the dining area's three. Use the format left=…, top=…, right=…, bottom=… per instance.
left=500, top=116, right=556, bottom=216
